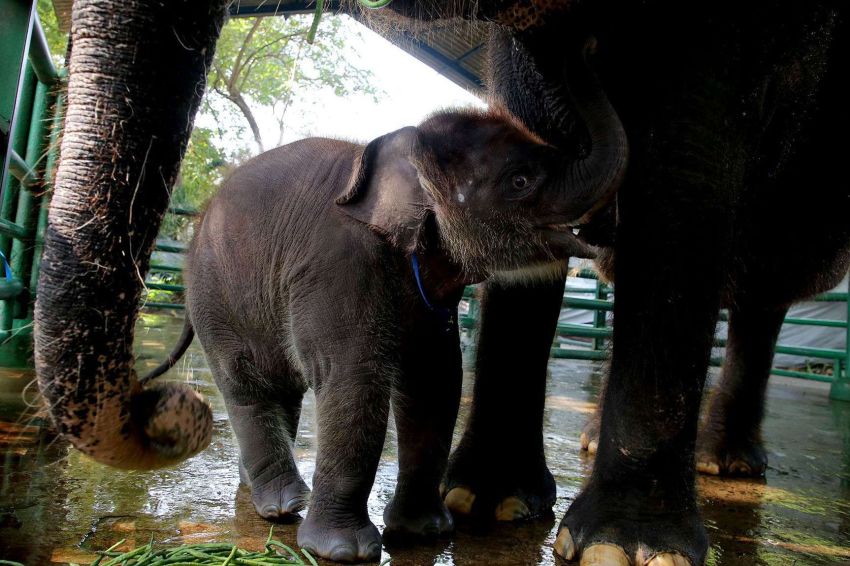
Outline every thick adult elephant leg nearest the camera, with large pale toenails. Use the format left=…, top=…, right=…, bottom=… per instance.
left=555, top=188, right=728, bottom=566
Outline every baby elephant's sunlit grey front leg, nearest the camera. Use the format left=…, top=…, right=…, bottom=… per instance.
left=298, top=360, right=388, bottom=562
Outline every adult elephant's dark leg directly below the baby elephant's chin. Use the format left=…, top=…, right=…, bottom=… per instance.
left=445, top=279, right=565, bottom=521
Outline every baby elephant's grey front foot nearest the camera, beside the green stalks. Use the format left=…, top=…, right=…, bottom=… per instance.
left=298, top=513, right=381, bottom=562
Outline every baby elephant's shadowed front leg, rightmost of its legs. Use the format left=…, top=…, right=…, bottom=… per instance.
left=384, top=318, right=463, bottom=536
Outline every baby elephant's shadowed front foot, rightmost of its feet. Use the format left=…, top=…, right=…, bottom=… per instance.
left=384, top=488, right=454, bottom=539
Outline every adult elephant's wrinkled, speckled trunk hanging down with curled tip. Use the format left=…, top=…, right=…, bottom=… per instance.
left=35, top=0, right=226, bottom=469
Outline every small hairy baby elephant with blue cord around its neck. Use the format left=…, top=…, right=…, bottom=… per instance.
left=149, top=97, right=611, bottom=561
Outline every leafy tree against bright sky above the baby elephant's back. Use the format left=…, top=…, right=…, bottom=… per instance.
left=161, top=15, right=377, bottom=240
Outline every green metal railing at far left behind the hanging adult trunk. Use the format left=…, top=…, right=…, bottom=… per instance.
left=0, top=0, right=63, bottom=367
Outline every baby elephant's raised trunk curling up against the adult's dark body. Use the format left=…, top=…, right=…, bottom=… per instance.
left=557, top=38, right=629, bottom=226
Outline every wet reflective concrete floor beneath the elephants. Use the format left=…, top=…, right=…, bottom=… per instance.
left=0, top=315, right=850, bottom=566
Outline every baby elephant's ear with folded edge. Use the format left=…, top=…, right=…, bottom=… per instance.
left=336, top=127, right=432, bottom=244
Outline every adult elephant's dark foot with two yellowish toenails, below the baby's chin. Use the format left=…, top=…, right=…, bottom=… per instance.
left=440, top=442, right=555, bottom=521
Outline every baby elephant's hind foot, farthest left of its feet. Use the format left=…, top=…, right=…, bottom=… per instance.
left=239, top=465, right=310, bottom=521
